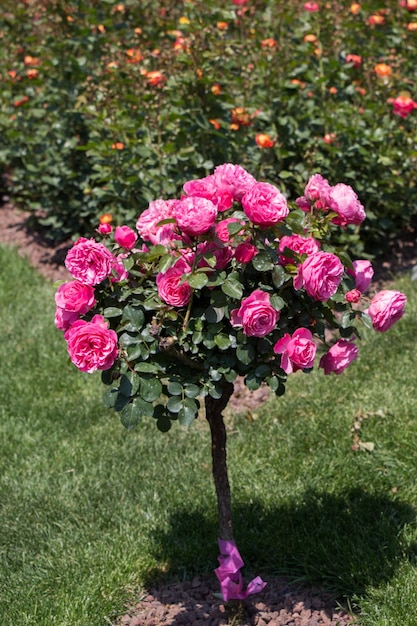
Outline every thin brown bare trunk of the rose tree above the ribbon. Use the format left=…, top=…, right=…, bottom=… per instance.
left=205, top=382, right=233, bottom=540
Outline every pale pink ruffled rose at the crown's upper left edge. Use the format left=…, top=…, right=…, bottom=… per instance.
left=136, top=198, right=179, bottom=246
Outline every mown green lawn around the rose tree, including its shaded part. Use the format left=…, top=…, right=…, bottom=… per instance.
left=0, top=247, right=417, bottom=626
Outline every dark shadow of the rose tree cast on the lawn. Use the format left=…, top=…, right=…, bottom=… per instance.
left=149, top=488, right=417, bottom=597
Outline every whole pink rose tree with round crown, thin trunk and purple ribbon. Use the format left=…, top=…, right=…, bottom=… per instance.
left=55, top=163, right=406, bottom=600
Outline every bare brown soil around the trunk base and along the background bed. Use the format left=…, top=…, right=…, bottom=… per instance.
left=0, top=199, right=417, bottom=626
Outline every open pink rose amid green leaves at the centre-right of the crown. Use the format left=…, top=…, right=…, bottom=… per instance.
left=230, top=289, right=279, bottom=337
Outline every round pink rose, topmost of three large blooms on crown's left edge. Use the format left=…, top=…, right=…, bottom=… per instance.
left=65, top=237, right=114, bottom=285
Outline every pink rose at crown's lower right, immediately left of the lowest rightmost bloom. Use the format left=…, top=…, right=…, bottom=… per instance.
left=274, top=328, right=317, bottom=374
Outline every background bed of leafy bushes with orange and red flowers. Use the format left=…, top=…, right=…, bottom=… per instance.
left=0, top=0, right=417, bottom=254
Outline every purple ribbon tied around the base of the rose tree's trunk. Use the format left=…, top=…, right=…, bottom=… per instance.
left=214, top=539, right=266, bottom=602
